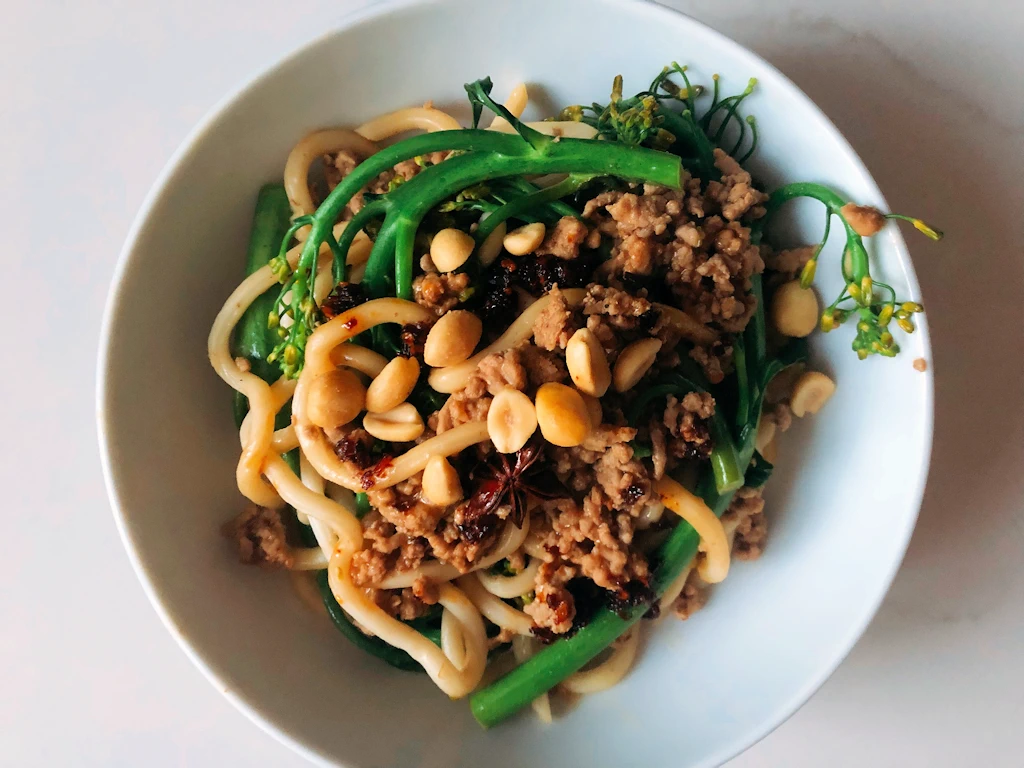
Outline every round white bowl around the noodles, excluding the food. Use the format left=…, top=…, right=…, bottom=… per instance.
left=98, top=0, right=932, bottom=768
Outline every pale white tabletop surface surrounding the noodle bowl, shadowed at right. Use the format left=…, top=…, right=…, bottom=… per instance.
left=0, top=0, right=1024, bottom=768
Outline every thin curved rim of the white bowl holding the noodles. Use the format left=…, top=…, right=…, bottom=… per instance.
left=96, top=0, right=935, bottom=766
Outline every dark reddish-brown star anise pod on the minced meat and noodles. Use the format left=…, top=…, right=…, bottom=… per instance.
left=466, top=440, right=568, bottom=526
